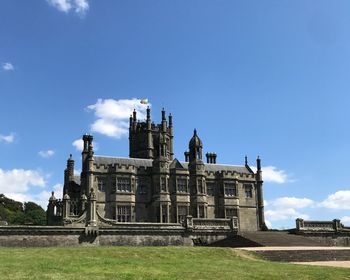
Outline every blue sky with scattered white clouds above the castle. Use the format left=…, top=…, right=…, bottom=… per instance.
left=0, top=0, right=350, bottom=228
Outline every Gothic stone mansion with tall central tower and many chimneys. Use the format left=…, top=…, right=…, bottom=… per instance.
left=48, top=108, right=264, bottom=231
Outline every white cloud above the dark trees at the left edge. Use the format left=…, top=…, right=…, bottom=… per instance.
left=0, top=169, right=46, bottom=193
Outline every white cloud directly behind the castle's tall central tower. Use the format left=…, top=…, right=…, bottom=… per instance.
left=87, top=98, right=150, bottom=138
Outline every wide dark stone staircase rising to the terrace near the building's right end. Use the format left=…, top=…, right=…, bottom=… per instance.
left=209, top=231, right=324, bottom=248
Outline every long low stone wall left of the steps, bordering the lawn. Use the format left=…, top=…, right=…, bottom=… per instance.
left=0, top=223, right=233, bottom=247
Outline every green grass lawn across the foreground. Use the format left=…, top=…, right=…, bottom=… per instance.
left=0, top=247, right=350, bottom=280
